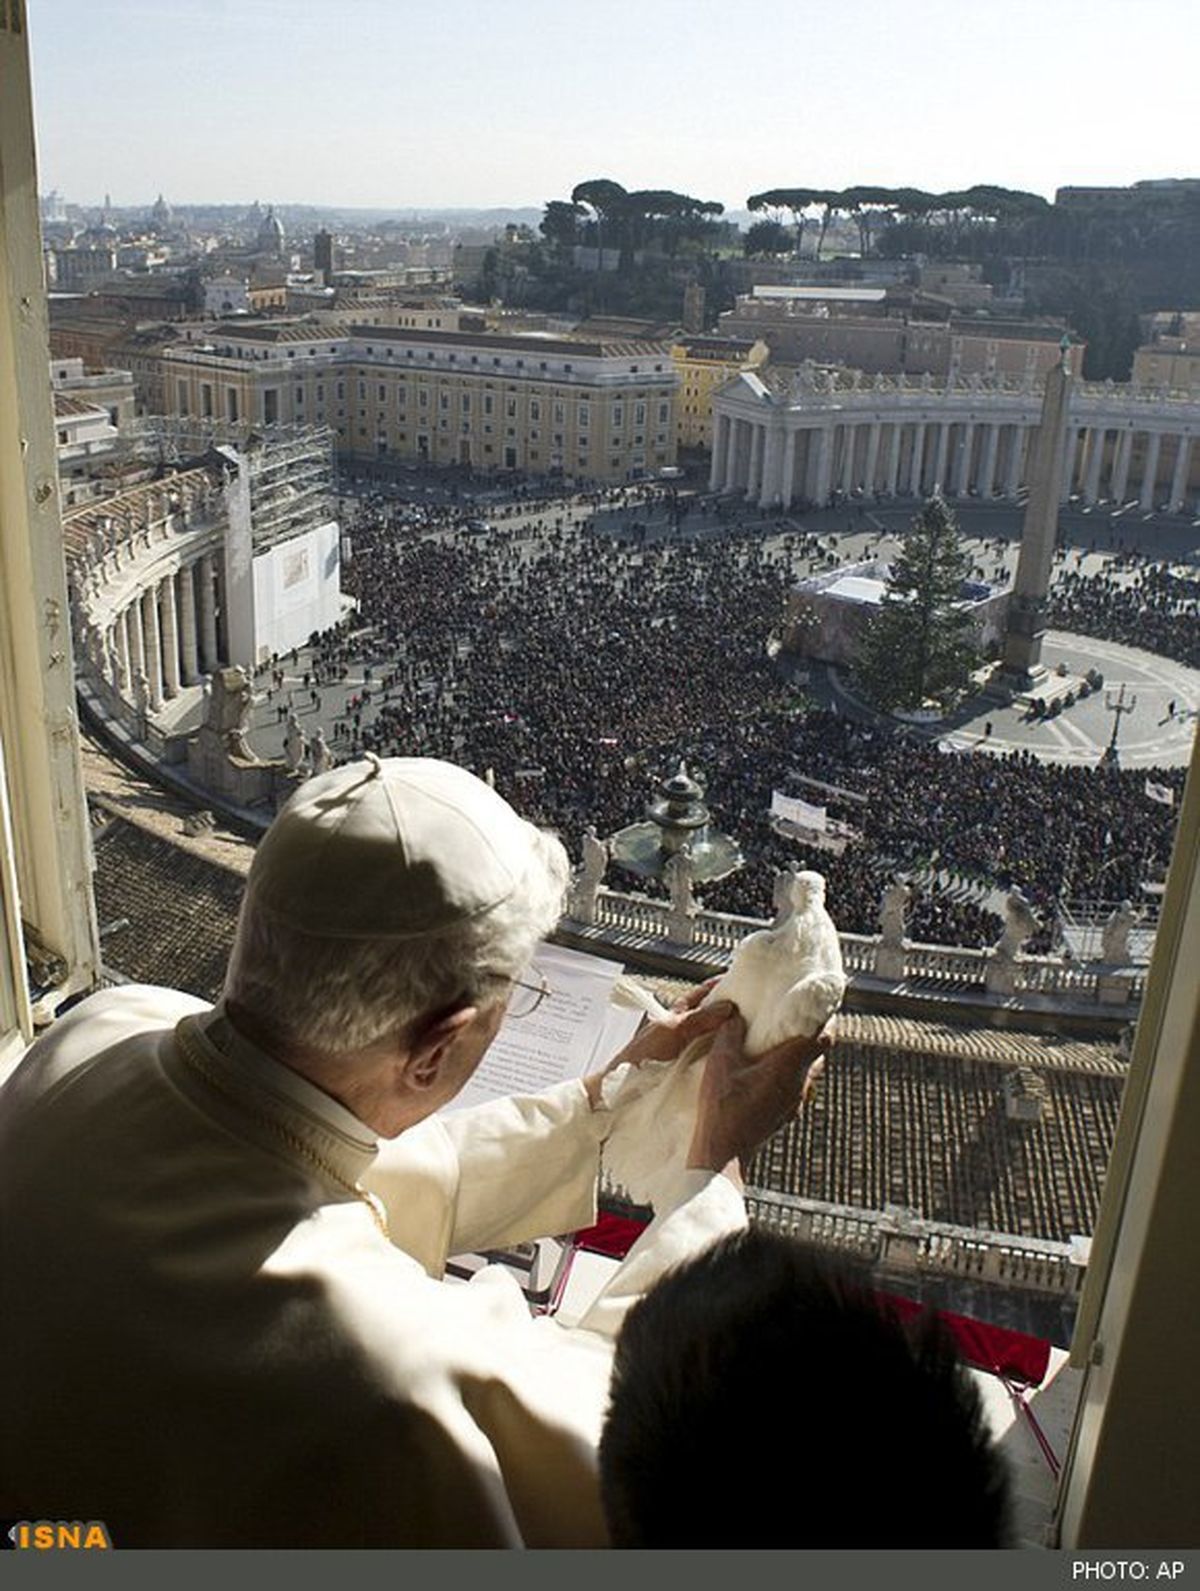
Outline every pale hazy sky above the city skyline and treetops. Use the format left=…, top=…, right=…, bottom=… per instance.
left=29, top=0, right=1200, bottom=208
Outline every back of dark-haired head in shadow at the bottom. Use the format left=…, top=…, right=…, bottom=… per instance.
left=600, top=1230, right=1007, bottom=1548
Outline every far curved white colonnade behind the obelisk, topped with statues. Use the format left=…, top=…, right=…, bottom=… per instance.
left=710, top=393, right=1200, bottom=514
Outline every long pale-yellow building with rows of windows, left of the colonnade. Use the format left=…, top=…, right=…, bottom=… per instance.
left=162, top=323, right=678, bottom=482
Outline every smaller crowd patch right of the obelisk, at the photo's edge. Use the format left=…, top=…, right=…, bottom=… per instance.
left=1049, top=552, right=1200, bottom=668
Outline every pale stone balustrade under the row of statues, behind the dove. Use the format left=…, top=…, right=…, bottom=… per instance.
left=562, top=888, right=1144, bottom=1006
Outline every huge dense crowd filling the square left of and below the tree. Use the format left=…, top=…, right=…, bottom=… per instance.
left=314, top=488, right=1182, bottom=945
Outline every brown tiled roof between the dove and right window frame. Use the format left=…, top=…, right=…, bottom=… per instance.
left=746, top=1015, right=1124, bottom=1243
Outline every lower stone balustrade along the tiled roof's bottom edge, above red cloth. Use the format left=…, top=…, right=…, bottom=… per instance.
left=746, top=1187, right=1085, bottom=1297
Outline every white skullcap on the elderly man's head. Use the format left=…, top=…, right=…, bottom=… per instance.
left=247, top=756, right=541, bottom=939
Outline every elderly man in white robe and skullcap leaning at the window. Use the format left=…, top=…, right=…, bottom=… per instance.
left=0, top=759, right=821, bottom=1546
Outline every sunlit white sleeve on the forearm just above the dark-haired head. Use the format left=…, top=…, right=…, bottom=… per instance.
left=579, top=1171, right=746, bottom=1338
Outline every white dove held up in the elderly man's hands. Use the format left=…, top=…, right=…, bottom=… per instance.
left=602, top=872, right=847, bottom=1204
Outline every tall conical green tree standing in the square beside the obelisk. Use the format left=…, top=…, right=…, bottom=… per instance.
left=855, top=496, right=979, bottom=711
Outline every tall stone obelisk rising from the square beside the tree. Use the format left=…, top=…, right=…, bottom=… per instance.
left=1001, top=334, right=1071, bottom=692
